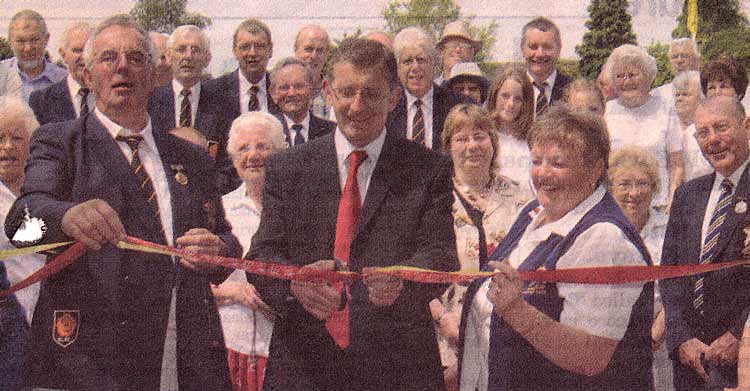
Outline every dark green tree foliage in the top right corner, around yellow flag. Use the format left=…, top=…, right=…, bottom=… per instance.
left=672, top=0, right=750, bottom=67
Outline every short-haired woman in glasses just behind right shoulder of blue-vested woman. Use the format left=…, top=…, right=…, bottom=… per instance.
left=609, top=146, right=674, bottom=390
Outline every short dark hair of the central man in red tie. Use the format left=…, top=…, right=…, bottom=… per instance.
left=328, top=38, right=399, bottom=88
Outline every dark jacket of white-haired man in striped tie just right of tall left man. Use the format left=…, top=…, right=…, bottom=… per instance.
left=149, top=83, right=242, bottom=194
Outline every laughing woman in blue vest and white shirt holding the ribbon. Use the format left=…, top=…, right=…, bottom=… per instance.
left=460, top=106, right=653, bottom=391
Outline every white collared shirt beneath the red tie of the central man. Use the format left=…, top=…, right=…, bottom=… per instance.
left=333, top=126, right=385, bottom=199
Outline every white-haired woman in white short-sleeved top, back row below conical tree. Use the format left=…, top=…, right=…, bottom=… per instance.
left=604, top=45, right=684, bottom=210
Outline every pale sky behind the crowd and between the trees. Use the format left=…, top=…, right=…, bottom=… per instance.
left=0, top=0, right=750, bottom=75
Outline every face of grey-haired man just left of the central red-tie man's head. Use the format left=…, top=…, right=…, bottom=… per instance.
left=271, top=65, right=312, bottom=119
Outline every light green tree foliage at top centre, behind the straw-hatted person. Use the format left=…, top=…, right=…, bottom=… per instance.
left=383, top=0, right=497, bottom=62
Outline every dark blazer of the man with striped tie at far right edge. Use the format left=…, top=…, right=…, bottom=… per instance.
left=659, top=170, right=750, bottom=388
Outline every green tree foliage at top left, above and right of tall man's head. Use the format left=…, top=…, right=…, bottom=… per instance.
left=130, top=0, right=211, bottom=33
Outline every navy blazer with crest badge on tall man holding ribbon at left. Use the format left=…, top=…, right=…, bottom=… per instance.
left=5, top=114, right=241, bottom=391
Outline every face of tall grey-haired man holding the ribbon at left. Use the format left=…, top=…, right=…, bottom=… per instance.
left=84, top=25, right=154, bottom=118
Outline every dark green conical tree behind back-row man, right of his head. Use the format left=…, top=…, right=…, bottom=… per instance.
left=576, top=0, right=636, bottom=78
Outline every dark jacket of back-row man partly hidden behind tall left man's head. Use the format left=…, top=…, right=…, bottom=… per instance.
left=29, top=78, right=77, bottom=126
